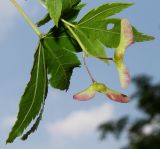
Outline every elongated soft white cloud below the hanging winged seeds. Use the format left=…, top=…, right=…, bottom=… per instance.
left=46, top=104, right=113, bottom=137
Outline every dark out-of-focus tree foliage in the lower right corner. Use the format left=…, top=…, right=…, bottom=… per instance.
left=98, top=75, right=160, bottom=149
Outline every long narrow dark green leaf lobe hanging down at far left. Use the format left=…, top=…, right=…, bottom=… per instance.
left=7, top=44, right=48, bottom=143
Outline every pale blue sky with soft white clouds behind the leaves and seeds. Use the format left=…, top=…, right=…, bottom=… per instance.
left=0, top=0, right=160, bottom=149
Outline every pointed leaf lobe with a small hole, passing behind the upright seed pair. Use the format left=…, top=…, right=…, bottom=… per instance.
left=77, top=18, right=154, bottom=48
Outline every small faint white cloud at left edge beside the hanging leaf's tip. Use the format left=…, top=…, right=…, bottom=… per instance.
left=1, top=116, right=16, bottom=129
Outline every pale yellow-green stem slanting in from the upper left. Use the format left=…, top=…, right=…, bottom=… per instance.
left=10, top=0, right=42, bottom=37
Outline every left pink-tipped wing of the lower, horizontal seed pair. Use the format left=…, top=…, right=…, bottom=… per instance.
left=73, top=87, right=96, bottom=101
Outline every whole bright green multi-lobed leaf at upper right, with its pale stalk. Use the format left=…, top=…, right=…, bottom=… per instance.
left=63, top=3, right=153, bottom=63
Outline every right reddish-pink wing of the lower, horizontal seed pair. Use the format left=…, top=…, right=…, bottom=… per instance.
left=106, top=89, right=129, bottom=103
